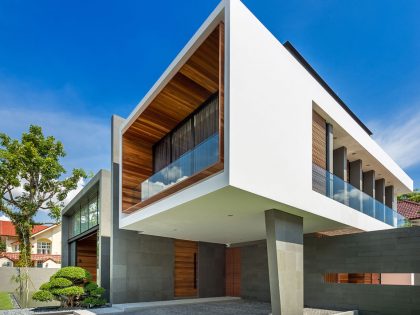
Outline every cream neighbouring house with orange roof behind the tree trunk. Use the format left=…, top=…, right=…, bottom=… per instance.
left=0, top=221, right=61, bottom=268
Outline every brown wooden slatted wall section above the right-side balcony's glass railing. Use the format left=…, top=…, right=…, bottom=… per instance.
left=312, top=111, right=327, bottom=169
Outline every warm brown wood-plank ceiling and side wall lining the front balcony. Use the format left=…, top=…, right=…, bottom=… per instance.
left=122, top=24, right=223, bottom=212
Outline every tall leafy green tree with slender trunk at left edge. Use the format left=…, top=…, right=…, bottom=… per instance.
left=0, top=125, right=86, bottom=266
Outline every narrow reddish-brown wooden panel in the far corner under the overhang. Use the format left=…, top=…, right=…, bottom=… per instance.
left=225, top=247, right=241, bottom=296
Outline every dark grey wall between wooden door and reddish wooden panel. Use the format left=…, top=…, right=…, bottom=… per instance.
left=198, top=242, right=226, bottom=298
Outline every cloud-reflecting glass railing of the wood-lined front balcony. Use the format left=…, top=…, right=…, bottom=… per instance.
left=141, top=133, right=219, bottom=201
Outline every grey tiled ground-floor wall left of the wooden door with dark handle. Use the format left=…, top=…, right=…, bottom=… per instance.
left=111, top=228, right=174, bottom=303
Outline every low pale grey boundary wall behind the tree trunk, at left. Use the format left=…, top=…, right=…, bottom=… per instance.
left=0, top=267, right=58, bottom=292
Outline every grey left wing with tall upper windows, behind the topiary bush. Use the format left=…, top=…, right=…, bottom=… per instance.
left=61, top=170, right=111, bottom=298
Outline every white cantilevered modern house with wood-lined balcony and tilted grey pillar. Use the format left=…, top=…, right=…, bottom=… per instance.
left=106, top=0, right=413, bottom=314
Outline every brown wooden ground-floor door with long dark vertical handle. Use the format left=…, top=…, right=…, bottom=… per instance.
left=174, top=240, right=198, bottom=297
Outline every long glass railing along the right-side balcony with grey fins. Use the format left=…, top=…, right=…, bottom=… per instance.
left=312, top=164, right=406, bottom=227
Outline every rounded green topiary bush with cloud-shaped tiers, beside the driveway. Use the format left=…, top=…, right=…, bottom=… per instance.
left=32, top=267, right=106, bottom=307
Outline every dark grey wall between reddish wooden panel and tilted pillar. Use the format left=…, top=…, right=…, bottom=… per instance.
left=241, top=240, right=270, bottom=302
